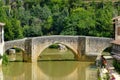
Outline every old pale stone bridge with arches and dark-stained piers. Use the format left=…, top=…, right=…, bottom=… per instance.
left=4, top=35, right=112, bottom=62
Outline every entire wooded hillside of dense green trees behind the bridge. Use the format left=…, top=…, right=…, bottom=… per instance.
left=0, top=0, right=120, bottom=41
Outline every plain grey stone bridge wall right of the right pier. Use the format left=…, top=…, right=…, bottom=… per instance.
left=85, top=37, right=113, bottom=56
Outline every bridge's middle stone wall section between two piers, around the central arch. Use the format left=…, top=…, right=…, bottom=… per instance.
left=32, top=36, right=80, bottom=62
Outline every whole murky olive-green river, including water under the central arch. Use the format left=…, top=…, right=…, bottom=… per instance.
left=0, top=49, right=97, bottom=80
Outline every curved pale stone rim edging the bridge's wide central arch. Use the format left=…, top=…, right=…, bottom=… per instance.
left=36, top=42, right=80, bottom=59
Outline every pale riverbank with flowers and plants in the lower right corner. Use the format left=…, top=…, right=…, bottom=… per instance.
left=98, top=56, right=120, bottom=80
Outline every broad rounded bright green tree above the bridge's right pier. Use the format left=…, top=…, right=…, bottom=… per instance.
left=63, top=7, right=95, bottom=35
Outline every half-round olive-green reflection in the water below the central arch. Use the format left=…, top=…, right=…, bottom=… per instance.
left=38, top=61, right=79, bottom=77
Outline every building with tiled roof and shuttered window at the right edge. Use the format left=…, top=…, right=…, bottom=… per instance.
left=111, top=16, right=120, bottom=62
